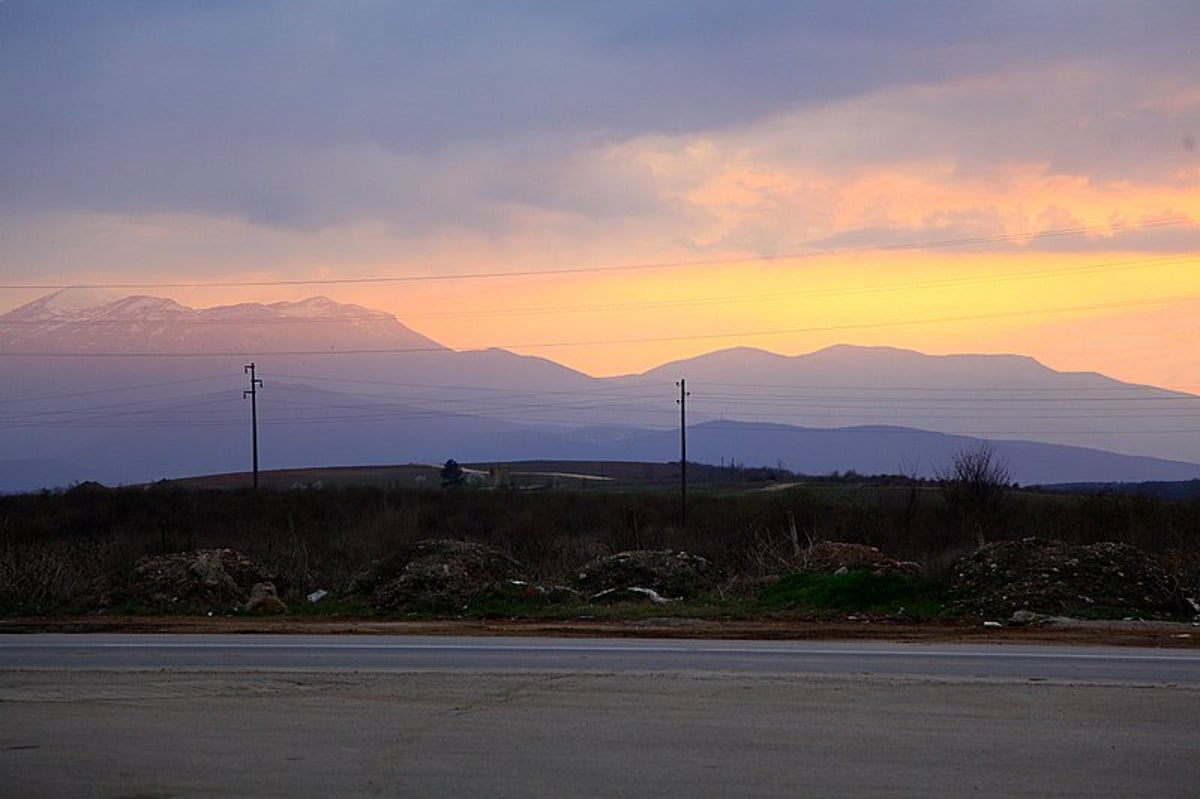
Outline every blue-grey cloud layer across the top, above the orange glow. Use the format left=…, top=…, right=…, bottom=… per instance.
left=0, top=0, right=1200, bottom=229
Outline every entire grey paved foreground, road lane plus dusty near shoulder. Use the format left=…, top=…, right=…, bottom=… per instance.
left=7, top=636, right=1200, bottom=799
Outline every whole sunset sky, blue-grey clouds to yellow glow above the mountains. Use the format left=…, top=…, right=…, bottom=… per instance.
left=0, top=0, right=1200, bottom=391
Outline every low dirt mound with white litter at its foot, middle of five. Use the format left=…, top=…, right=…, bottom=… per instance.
left=575, top=549, right=718, bottom=599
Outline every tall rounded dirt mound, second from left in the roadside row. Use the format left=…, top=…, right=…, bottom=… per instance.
left=343, top=540, right=524, bottom=611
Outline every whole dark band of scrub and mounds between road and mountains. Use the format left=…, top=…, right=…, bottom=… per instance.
left=0, top=453, right=1200, bottom=620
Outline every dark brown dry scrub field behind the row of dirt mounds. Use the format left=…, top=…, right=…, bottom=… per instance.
left=0, top=475, right=1200, bottom=613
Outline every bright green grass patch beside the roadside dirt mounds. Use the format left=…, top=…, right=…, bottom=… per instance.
left=758, top=569, right=946, bottom=618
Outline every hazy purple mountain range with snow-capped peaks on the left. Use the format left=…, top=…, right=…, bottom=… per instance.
left=0, top=289, right=1200, bottom=491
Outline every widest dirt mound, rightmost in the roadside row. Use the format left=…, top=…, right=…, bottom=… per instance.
left=952, top=539, right=1183, bottom=618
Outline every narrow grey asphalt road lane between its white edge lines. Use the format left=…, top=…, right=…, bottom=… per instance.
left=0, top=635, right=1200, bottom=685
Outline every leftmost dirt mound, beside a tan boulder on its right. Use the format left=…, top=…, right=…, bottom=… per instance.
left=124, top=549, right=268, bottom=611
